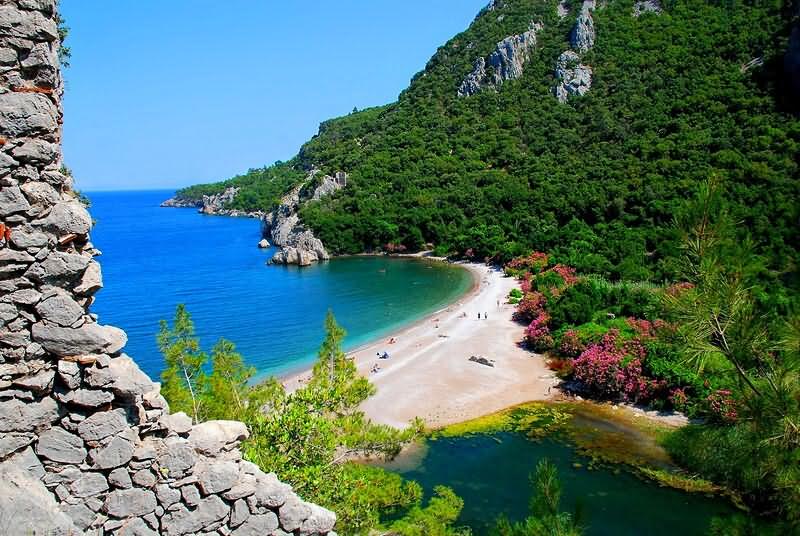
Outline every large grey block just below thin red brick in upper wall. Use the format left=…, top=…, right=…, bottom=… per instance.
left=0, top=90, right=58, bottom=138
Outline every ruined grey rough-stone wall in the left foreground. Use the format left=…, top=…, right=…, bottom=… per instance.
left=0, top=0, right=335, bottom=536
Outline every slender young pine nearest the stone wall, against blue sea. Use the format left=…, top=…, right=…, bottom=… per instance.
left=156, top=304, right=207, bottom=423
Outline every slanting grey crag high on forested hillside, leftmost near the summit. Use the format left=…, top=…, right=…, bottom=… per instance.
left=458, top=23, right=542, bottom=97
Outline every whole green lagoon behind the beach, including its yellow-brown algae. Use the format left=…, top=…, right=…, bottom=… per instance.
left=381, top=404, right=736, bottom=536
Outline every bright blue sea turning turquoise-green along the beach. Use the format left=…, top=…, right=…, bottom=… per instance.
left=89, top=191, right=472, bottom=377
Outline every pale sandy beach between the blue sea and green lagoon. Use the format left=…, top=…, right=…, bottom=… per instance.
left=284, top=264, right=558, bottom=428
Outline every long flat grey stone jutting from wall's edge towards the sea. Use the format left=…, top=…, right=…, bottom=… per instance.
left=32, top=322, right=128, bottom=356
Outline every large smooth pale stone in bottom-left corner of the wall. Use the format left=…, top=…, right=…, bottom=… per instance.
left=0, top=453, right=78, bottom=536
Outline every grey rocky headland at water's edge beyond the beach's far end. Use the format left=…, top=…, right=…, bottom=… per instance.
left=262, top=170, right=340, bottom=266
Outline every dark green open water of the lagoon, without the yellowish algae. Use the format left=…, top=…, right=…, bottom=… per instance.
left=387, top=432, right=734, bottom=536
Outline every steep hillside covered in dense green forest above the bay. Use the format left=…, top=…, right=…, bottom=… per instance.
left=172, top=0, right=800, bottom=294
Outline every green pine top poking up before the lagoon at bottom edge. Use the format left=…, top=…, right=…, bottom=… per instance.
left=492, top=459, right=583, bottom=536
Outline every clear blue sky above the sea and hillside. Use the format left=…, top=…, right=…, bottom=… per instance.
left=61, top=0, right=488, bottom=191
